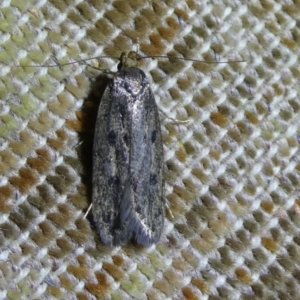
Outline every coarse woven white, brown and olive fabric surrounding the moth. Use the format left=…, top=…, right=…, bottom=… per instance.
left=0, top=0, right=300, bottom=300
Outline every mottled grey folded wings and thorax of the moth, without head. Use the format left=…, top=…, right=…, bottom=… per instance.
left=93, top=67, right=164, bottom=246
